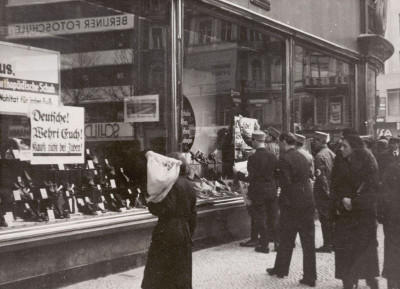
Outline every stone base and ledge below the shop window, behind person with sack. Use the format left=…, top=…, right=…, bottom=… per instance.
left=0, top=196, right=250, bottom=289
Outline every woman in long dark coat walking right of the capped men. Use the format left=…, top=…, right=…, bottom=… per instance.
left=332, top=135, right=379, bottom=289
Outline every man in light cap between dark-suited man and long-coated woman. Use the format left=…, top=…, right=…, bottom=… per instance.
left=313, top=131, right=336, bottom=253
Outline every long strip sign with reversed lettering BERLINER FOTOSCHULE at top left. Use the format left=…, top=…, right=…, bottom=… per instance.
left=7, top=14, right=133, bottom=39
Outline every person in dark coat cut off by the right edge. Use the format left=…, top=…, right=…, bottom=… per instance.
left=378, top=161, right=400, bottom=289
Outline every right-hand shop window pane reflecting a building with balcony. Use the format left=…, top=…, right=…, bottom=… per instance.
left=293, top=46, right=354, bottom=133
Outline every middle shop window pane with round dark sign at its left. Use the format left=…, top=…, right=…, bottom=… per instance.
left=182, top=6, right=285, bottom=176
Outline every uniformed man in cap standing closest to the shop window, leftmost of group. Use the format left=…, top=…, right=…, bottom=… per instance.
left=237, top=130, right=278, bottom=253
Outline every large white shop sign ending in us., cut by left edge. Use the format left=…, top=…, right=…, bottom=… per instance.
left=0, top=42, right=60, bottom=115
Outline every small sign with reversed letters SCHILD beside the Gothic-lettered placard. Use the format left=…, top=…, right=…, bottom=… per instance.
left=85, top=122, right=134, bottom=141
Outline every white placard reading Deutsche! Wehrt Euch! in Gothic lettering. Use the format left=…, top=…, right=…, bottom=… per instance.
left=30, top=106, right=85, bottom=164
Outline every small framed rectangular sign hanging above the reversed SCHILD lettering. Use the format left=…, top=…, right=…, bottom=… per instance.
left=124, top=94, right=160, bottom=122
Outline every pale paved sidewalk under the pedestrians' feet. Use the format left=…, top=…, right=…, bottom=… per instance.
left=63, top=221, right=386, bottom=289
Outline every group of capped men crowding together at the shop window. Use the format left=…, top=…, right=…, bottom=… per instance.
left=237, top=128, right=335, bottom=287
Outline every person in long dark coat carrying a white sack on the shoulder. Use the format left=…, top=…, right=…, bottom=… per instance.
left=142, top=153, right=197, bottom=289
